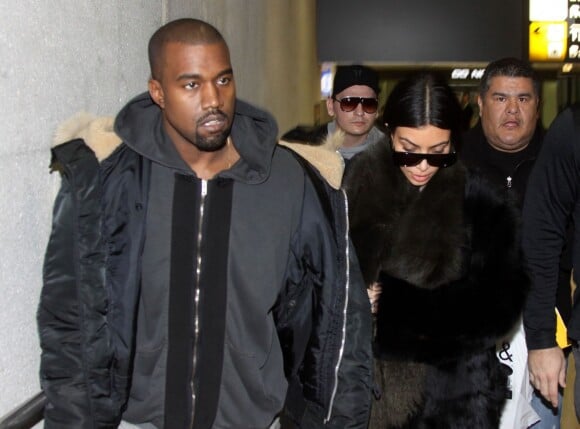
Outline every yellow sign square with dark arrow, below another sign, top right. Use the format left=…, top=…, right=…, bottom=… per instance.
left=529, top=21, right=568, bottom=61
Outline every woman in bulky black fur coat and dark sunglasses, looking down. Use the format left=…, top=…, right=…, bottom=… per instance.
left=344, top=73, right=528, bottom=429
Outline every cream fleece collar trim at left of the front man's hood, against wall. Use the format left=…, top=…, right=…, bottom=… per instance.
left=53, top=112, right=121, bottom=162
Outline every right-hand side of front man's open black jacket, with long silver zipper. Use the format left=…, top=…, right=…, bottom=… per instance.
left=278, top=175, right=372, bottom=429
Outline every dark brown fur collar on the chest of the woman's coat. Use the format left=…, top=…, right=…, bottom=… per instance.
left=379, top=165, right=467, bottom=289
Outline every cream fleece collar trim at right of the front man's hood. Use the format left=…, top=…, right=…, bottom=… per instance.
left=279, top=127, right=344, bottom=189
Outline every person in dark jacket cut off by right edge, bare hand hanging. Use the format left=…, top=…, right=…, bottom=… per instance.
left=523, top=106, right=580, bottom=417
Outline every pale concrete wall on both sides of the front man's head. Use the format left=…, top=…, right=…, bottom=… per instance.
left=0, top=0, right=317, bottom=416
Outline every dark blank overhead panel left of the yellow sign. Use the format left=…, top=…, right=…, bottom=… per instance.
left=317, top=0, right=528, bottom=63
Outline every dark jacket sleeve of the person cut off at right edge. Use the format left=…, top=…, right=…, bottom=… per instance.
left=523, top=109, right=580, bottom=349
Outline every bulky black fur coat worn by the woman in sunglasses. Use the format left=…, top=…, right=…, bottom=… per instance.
left=344, top=137, right=529, bottom=427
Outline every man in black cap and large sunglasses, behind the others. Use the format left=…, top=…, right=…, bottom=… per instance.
left=282, top=64, right=383, bottom=162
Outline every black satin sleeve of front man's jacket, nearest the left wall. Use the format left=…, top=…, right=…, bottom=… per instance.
left=37, top=159, right=90, bottom=429
